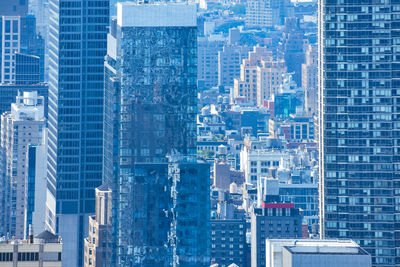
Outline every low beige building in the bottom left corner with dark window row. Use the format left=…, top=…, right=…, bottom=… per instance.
left=0, top=231, right=62, bottom=267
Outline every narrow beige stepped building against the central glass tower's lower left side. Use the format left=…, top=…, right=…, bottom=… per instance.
left=84, top=185, right=112, bottom=267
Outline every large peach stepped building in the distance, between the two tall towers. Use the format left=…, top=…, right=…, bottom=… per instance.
left=233, top=47, right=286, bottom=106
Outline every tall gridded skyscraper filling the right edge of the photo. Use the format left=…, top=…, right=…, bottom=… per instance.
left=319, top=0, right=400, bottom=266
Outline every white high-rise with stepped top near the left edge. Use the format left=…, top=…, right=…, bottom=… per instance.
left=1, top=92, right=47, bottom=239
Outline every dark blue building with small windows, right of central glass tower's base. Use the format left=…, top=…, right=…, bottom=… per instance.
left=211, top=219, right=247, bottom=267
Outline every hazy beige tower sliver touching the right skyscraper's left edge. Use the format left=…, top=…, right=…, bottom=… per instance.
left=301, top=45, right=318, bottom=115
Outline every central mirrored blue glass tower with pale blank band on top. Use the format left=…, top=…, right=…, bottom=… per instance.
left=104, top=3, right=210, bottom=267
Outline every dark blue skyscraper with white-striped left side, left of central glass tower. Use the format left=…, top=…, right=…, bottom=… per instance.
left=48, top=0, right=109, bottom=267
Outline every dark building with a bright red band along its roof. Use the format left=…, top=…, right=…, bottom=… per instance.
left=251, top=202, right=302, bottom=267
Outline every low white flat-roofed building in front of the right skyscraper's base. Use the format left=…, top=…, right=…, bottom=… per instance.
left=265, top=239, right=372, bottom=267
